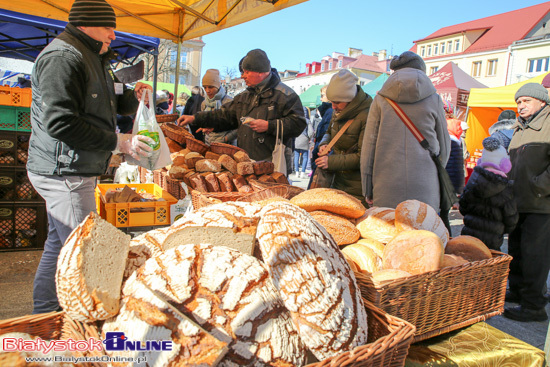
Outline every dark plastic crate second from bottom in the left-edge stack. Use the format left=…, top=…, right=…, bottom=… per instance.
left=0, top=167, right=43, bottom=202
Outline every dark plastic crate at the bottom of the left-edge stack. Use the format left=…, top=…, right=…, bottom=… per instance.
left=0, top=202, right=48, bottom=251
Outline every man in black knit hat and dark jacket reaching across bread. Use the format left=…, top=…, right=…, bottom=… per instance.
left=178, top=49, right=306, bottom=161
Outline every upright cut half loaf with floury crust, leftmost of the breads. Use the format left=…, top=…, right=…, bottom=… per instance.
left=55, top=212, right=130, bottom=322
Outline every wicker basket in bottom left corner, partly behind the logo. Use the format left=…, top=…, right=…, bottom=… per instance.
left=0, top=312, right=105, bottom=367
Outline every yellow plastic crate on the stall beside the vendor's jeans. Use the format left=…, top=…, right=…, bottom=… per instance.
left=95, top=184, right=178, bottom=227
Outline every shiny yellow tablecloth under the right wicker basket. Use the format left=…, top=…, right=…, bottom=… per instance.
left=405, top=322, right=545, bottom=367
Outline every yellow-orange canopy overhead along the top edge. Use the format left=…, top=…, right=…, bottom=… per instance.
left=1, top=0, right=307, bottom=42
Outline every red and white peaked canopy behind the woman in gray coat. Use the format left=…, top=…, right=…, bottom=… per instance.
left=430, top=61, right=487, bottom=109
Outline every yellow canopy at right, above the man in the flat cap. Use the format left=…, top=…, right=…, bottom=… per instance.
left=466, top=73, right=548, bottom=154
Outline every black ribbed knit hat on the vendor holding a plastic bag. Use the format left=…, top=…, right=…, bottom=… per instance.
left=69, top=0, right=116, bottom=28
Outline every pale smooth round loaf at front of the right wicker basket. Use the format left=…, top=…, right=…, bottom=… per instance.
left=383, top=230, right=444, bottom=274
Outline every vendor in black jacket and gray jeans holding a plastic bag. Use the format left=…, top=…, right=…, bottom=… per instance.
left=27, top=0, right=154, bottom=313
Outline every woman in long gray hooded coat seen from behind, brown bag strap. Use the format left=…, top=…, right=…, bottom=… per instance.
left=361, top=51, right=451, bottom=212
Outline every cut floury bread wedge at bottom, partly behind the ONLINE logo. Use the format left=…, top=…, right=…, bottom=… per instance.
left=101, top=273, right=230, bottom=367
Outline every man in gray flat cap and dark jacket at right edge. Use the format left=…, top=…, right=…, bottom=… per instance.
left=504, top=83, right=550, bottom=321
